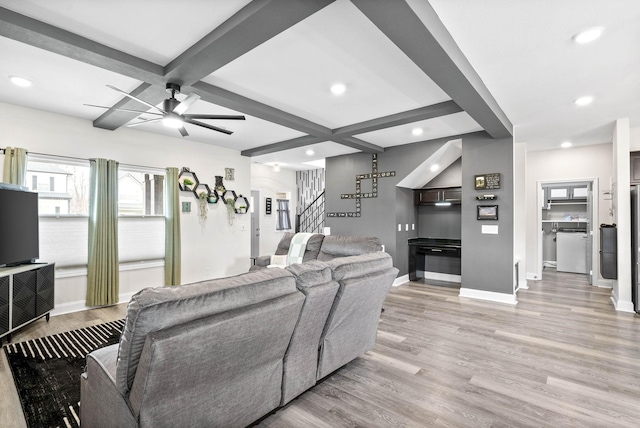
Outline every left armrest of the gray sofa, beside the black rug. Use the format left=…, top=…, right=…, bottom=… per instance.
left=80, top=344, right=137, bottom=428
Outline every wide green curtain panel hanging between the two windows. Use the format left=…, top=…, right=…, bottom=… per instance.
left=87, top=159, right=120, bottom=306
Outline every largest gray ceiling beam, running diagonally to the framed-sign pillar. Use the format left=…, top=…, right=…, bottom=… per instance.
left=351, top=0, right=513, bottom=138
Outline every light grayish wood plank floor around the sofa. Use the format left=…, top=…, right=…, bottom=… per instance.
left=0, top=269, right=640, bottom=428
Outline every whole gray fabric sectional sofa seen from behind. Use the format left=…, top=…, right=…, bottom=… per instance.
left=80, top=237, right=398, bottom=428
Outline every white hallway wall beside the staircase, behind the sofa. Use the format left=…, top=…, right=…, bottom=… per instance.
left=251, top=163, right=297, bottom=255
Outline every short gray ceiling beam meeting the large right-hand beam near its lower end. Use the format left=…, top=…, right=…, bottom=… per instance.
left=333, top=101, right=462, bottom=137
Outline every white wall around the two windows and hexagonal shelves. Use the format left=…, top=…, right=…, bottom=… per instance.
left=0, top=103, right=251, bottom=313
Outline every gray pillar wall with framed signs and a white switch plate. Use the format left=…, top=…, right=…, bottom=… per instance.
left=462, top=134, right=514, bottom=295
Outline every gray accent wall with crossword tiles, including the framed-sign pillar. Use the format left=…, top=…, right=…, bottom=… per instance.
left=325, top=132, right=514, bottom=300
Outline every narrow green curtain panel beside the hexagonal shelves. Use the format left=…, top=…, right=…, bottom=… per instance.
left=164, top=168, right=182, bottom=285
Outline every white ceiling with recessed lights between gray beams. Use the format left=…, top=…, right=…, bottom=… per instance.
left=0, top=0, right=640, bottom=169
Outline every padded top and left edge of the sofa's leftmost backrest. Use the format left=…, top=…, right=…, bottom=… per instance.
left=116, top=269, right=297, bottom=394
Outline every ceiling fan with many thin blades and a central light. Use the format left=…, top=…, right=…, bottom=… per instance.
left=85, top=83, right=245, bottom=137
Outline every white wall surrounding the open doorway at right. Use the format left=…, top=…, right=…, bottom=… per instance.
left=525, top=144, right=613, bottom=281
